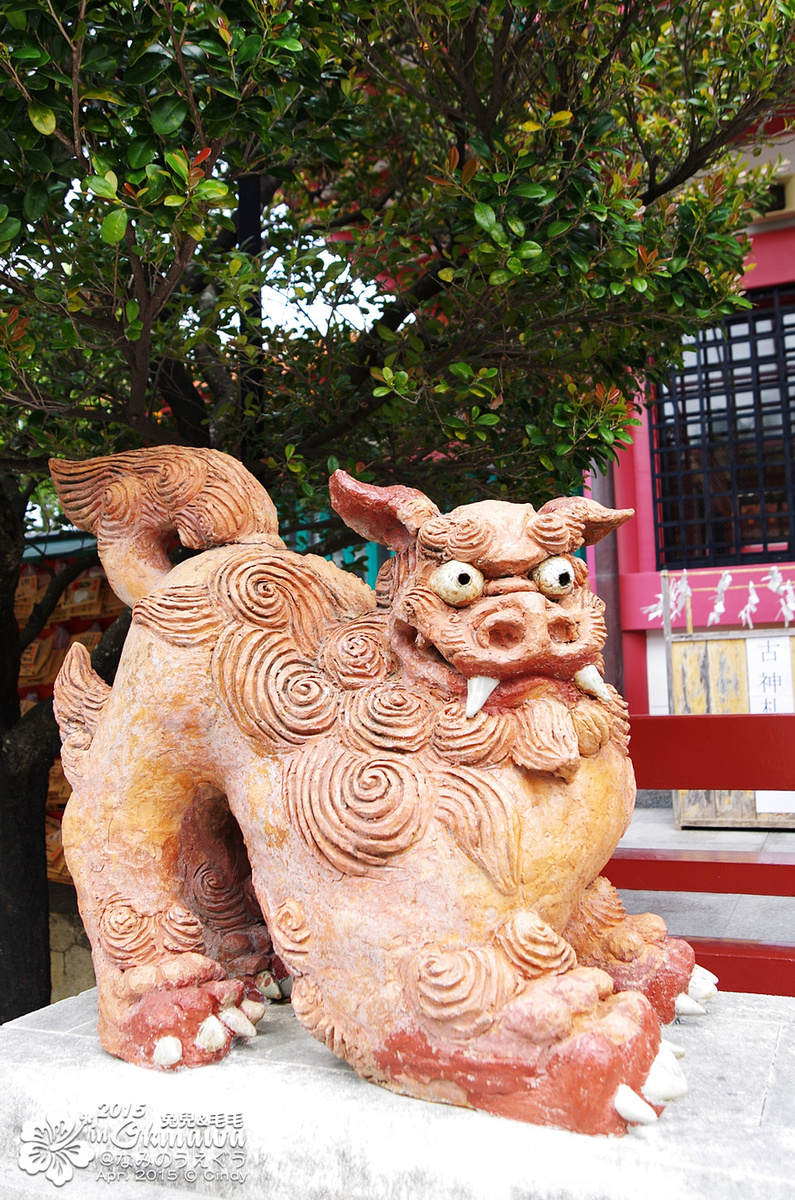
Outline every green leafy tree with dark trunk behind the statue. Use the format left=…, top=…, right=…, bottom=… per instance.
left=0, top=0, right=795, bottom=1015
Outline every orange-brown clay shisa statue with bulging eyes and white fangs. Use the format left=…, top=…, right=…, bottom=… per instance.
left=52, top=446, right=715, bottom=1134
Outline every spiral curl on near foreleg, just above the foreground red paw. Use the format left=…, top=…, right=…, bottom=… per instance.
left=407, top=947, right=516, bottom=1038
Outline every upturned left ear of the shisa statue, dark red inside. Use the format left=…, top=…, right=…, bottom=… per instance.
left=329, top=470, right=438, bottom=550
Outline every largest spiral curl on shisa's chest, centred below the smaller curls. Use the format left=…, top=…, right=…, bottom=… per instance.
left=286, top=740, right=429, bottom=875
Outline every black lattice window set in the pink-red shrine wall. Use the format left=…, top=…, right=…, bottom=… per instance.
left=650, top=284, right=795, bottom=568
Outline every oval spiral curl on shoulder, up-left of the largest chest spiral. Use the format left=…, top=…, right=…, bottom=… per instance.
left=213, top=626, right=337, bottom=745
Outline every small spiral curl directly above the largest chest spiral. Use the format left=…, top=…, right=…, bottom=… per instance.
left=340, top=686, right=432, bottom=754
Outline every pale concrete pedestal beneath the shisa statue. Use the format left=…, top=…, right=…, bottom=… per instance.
left=0, top=992, right=795, bottom=1200
